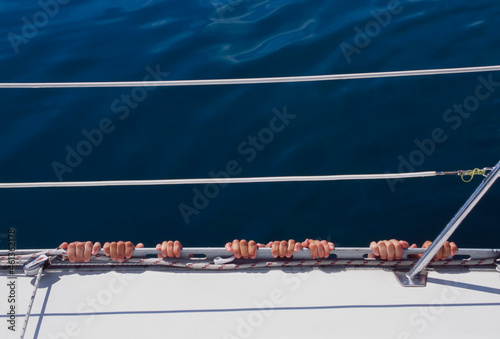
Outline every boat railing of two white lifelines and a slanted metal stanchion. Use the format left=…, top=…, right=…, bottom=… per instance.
left=0, top=65, right=500, bottom=286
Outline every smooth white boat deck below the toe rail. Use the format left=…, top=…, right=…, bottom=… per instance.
left=0, top=268, right=500, bottom=339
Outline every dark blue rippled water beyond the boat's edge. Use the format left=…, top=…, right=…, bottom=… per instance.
left=0, top=0, right=500, bottom=248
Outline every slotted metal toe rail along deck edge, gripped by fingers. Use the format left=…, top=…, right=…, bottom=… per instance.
left=0, top=247, right=500, bottom=269
